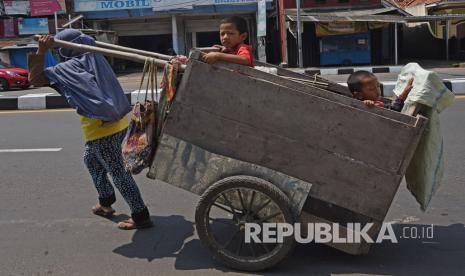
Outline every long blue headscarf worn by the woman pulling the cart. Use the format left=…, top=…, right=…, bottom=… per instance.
left=44, top=29, right=131, bottom=122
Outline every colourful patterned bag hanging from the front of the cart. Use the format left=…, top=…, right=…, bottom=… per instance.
left=122, top=59, right=158, bottom=174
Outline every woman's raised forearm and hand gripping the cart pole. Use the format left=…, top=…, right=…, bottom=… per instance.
left=27, top=36, right=51, bottom=87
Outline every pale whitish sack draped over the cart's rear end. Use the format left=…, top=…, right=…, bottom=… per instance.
left=394, top=63, right=455, bottom=211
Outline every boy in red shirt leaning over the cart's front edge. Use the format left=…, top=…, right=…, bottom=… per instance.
left=203, top=16, right=255, bottom=67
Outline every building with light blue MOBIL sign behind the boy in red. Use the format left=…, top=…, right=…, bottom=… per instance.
left=74, top=0, right=273, bottom=67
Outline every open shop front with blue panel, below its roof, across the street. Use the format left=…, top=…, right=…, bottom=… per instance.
left=286, top=10, right=404, bottom=67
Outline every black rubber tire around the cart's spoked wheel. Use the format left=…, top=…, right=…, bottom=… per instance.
left=195, top=175, right=295, bottom=271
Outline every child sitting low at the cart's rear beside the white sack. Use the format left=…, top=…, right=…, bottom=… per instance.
left=347, top=71, right=413, bottom=112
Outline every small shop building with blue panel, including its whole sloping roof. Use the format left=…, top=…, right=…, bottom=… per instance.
left=278, top=0, right=406, bottom=67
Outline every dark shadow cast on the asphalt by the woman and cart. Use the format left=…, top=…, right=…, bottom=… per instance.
left=113, top=221, right=465, bottom=275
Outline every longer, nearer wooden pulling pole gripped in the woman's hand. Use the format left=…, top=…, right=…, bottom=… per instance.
left=34, top=35, right=179, bottom=69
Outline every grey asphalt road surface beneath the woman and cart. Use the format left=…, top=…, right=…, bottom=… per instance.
left=0, top=98, right=465, bottom=276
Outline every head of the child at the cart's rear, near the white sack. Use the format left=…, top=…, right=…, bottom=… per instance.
left=347, top=71, right=381, bottom=101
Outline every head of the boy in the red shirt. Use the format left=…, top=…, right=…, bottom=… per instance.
left=220, top=16, right=248, bottom=49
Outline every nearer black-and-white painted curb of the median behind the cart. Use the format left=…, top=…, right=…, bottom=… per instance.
left=0, top=83, right=465, bottom=110
